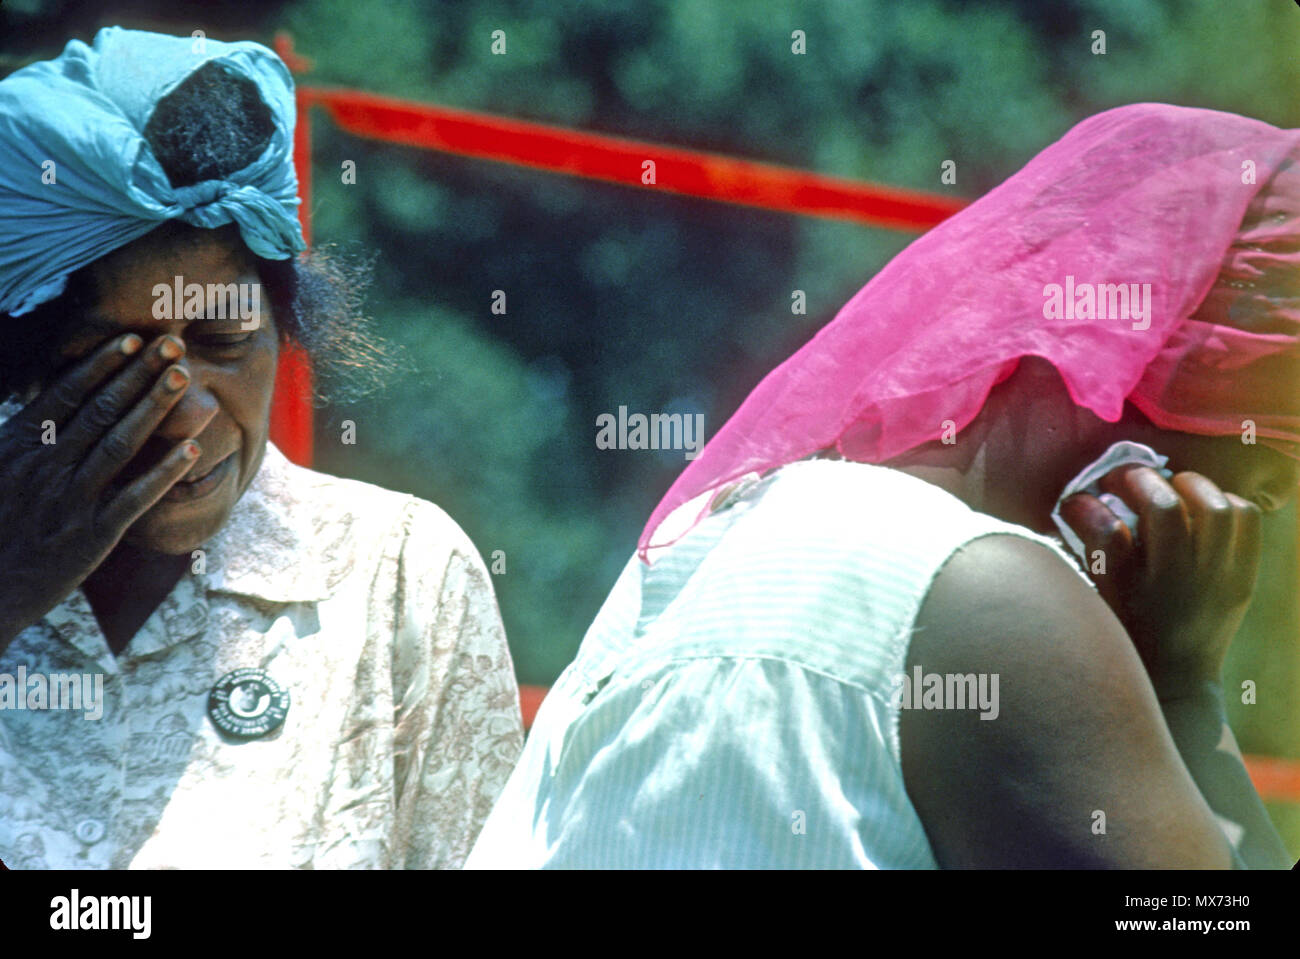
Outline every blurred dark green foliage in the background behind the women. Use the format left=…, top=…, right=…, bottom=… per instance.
left=0, top=0, right=1300, bottom=854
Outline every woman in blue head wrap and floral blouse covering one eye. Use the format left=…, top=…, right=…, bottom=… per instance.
left=0, top=27, right=521, bottom=868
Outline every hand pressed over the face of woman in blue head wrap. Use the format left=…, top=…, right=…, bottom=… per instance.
left=0, top=334, right=200, bottom=652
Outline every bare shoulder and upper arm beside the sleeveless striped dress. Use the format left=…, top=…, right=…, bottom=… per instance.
left=900, top=535, right=1229, bottom=868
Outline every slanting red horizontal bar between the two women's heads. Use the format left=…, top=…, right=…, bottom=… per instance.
left=299, top=87, right=966, bottom=230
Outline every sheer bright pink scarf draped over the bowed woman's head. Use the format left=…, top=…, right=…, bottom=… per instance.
left=640, top=104, right=1300, bottom=559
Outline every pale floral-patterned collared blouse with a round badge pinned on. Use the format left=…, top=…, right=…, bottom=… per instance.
left=0, top=444, right=523, bottom=869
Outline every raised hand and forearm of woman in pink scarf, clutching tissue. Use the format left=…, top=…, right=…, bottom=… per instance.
left=1062, top=467, right=1291, bottom=868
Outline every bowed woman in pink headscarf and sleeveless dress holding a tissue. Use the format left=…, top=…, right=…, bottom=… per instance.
left=469, top=104, right=1300, bottom=868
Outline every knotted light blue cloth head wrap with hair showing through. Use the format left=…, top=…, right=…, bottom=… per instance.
left=0, top=27, right=306, bottom=316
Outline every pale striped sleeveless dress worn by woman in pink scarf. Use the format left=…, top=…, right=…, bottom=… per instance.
left=467, top=460, right=1087, bottom=868
